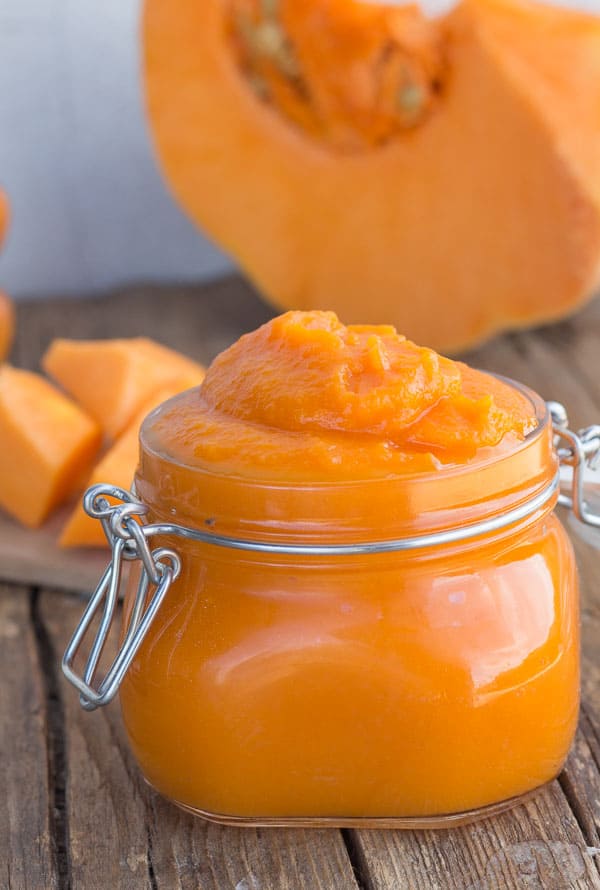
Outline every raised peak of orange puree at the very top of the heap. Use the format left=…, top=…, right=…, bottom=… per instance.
left=202, top=312, right=460, bottom=438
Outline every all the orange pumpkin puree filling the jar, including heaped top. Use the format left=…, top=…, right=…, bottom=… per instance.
left=120, top=312, right=579, bottom=822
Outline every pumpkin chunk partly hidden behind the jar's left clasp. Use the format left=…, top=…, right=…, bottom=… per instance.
left=59, top=380, right=204, bottom=547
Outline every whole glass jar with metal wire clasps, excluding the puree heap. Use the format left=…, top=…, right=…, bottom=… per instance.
left=63, top=381, right=600, bottom=827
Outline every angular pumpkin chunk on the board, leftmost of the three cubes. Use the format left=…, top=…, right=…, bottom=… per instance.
left=0, top=365, right=100, bottom=527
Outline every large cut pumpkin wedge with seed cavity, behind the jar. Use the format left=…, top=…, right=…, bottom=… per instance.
left=144, top=0, right=600, bottom=349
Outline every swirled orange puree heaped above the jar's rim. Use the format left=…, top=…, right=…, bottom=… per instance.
left=152, top=312, right=536, bottom=482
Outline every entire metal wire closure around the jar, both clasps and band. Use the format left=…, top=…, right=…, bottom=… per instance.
left=62, top=402, right=600, bottom=711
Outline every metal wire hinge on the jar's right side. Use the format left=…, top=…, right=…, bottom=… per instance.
left=547, top=402, right=600, bottom=529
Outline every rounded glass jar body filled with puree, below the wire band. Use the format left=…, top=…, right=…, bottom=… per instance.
left=120, top=500, right=579, bottom=824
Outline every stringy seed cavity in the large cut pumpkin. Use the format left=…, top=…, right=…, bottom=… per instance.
left=227, top=0, right=445, bottom=152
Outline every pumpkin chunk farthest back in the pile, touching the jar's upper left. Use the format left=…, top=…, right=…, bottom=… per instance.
left=42, top=337, right=204, bottom=439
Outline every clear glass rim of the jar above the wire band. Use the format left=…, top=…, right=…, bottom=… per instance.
left=135, top=372, right=558, bottom=542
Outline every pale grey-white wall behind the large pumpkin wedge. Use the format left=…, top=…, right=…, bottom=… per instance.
left=0, top=0, right=600, bottom=297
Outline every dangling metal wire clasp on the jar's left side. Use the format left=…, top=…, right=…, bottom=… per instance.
left=62, top=485, right=181, bottom=711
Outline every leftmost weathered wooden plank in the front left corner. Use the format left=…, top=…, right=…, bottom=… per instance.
left=0, top=586, right=59, bottom=890
